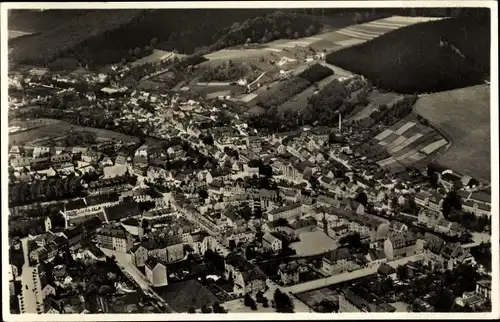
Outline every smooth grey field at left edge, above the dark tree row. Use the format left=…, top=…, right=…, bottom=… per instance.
left=9, top=120, right=139, bottom=145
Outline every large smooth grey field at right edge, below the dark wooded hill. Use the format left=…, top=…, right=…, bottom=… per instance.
left=414, top=85, right=491, bottom=182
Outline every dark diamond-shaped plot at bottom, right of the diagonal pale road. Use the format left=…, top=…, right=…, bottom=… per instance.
left=155, top=280, right=221, bottom=312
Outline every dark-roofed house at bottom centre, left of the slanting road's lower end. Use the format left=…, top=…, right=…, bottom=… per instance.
left=224, top=253, right=266, bottom=295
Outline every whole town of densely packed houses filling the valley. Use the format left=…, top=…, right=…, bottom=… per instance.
left=8, top=6, right=492, bottom=314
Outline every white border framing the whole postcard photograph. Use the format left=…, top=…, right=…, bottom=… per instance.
left=0, top=0, right=500, bottom=321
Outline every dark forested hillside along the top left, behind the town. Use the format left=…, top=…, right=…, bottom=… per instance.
left=10, top=9, right=270, bottom=65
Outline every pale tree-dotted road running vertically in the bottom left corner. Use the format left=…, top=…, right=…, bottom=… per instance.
left=18, top=238, right=43, bottom=313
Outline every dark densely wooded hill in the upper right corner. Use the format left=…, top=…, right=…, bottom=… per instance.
left=327, top=17, right=490, bottom=93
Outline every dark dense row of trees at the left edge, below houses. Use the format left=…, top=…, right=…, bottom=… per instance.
left=9, top=176, right=84, bottom=207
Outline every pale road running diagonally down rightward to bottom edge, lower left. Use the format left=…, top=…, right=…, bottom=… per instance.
left=100, top=248, right=176, bottom=313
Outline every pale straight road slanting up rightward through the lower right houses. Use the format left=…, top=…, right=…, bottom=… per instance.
left=282, top=254, right=424, bottom=294
